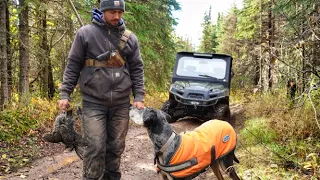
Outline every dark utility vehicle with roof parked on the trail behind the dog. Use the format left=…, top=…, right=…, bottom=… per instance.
left=161, top=52, right=233, bottom=123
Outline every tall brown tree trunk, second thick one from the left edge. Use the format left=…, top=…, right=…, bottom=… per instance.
left=19, top=0, right=30, bottom=103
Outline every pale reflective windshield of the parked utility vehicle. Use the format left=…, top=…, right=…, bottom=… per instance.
left=176, top=57, right=227, bottom=79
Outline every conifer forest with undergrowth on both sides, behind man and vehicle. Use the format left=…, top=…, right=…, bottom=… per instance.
left=0, top=0, right=320, bottom=179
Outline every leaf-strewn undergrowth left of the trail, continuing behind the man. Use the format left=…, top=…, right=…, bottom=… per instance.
left=0, top=89, right=167, bottom=175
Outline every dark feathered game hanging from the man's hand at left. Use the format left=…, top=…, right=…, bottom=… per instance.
left=42, top=108, right=85, bottom=159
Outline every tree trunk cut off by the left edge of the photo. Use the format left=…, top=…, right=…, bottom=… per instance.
left=0, top=0, right=8, bottom=107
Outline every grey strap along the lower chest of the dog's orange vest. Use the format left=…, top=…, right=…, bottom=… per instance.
left=157, top=158, right=198, bottom=173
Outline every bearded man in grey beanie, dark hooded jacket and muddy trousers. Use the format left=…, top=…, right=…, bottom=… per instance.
left=59, top=0, right=145, bottom=180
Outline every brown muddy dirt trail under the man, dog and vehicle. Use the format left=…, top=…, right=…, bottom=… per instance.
left=5, top=106, right=242, bottom=180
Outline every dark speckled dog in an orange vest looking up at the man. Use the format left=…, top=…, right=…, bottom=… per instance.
left=129, top=108, right=240, bottom=180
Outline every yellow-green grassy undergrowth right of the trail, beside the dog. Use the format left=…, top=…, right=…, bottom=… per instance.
left=234, top=90, right=320, bottom=180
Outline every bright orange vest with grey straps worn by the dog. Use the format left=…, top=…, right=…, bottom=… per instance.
left=157, top=120, right=236, bottom=178
